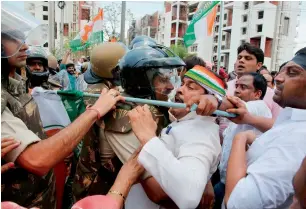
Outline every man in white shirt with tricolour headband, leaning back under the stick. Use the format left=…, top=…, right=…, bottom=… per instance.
left=125, top=66, right=225, bottom=209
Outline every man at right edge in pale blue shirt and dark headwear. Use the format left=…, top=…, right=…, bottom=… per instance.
left=219, top=48, right=306, bottom=209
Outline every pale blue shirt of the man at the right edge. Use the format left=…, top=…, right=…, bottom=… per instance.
left=227, top=108, right=306, bottom=209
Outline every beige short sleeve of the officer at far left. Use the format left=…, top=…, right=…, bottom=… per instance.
left=1, top=107, right=40, bottom=162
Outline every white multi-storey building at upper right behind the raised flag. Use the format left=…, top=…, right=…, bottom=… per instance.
left=188, top=1, right=301, bottom=72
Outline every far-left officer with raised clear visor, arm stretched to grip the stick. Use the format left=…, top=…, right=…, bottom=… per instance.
left=1, top=2, right=121, bottom=209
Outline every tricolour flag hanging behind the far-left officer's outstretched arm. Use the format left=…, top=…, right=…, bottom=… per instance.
left=31, top=87, right=86, bottom=208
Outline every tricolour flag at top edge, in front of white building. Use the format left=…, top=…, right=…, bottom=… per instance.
left=184, top=1, right=220, bottom=47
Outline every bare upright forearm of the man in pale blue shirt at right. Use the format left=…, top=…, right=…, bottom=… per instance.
left=224, top=136, right=247, bottom=204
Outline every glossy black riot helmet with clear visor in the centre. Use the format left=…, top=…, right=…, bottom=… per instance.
left=119, top=46, right=185, bottom=101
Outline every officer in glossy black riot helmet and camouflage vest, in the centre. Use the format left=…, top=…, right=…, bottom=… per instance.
left=73, top=39, right=184, bottom=200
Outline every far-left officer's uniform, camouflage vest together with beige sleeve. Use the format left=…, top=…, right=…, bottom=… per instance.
left=1, top=78, right=56, bottom=209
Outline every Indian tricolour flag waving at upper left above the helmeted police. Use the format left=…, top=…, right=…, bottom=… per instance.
left=70, top=9, right=103, bottom=51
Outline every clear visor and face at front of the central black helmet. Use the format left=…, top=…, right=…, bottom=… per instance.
left=146, top=68, right=180, bottom=101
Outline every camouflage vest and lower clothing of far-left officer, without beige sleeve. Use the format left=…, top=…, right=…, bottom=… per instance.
left=1, top=78, right=56, bottom=209
